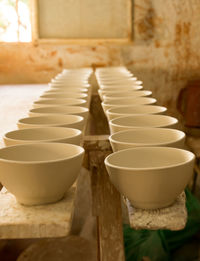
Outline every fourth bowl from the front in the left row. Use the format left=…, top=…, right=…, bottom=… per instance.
left=29, top=106, right=89, bottom=120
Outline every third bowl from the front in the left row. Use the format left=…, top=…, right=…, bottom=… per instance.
left=17, top=114, right=84, bottom=130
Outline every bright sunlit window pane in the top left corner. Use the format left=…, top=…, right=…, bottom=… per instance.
left=0, top=0, right=31, bottom=42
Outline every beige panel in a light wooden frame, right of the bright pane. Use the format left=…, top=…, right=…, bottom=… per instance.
left=33, top=0, right=133, bottom=43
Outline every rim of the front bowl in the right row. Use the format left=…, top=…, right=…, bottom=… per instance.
left=104, top=146, right=195, bottom=171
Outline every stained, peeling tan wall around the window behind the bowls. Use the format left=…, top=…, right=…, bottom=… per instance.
left=0, top=0, right=200, bottom=119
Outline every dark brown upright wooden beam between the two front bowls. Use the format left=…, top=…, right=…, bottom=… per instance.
left=84, top=139, right=125, bottom=261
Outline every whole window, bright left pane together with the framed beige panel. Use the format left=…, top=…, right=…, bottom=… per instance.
left=0, top=0, right=133, bottom=43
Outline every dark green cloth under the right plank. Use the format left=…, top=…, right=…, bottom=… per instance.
left=124, top=189, right=200, bottom=261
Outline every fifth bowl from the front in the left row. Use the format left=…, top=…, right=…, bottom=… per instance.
left=33, top=98, right=87, bottom=108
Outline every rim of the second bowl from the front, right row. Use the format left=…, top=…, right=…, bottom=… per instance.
left=108, top=127, right=186, bottom=147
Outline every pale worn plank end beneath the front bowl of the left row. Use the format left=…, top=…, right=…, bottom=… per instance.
left=0, top=183, right=76, bottom=239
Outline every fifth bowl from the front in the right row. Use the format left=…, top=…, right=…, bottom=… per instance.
left=101, top=97, right=157, bottom=113
